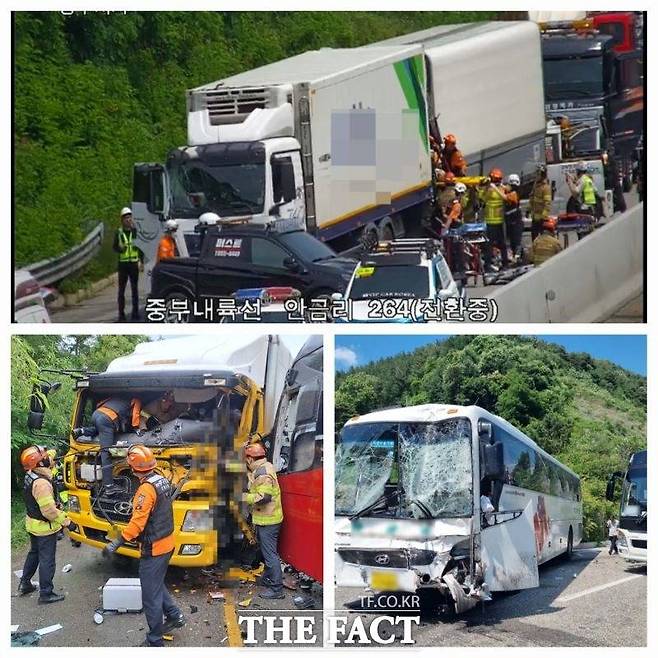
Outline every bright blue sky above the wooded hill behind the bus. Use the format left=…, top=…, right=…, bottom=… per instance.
left=336, top=334, right=647, bottom=377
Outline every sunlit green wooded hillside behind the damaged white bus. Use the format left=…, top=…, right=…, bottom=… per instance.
left=336, top=336, right=646, bottom=540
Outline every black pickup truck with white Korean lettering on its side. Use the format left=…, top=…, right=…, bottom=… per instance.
left=150, top=224, right=356, bottom=303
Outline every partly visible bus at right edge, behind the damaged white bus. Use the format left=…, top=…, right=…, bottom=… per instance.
left=606, top=450, right=647, bottom=562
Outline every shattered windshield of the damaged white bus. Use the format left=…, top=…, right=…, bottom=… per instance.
left=336, top=418, right=473, bottom=519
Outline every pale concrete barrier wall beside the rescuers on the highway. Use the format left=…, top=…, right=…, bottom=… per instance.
left=490, top=203, right=644, bottom=322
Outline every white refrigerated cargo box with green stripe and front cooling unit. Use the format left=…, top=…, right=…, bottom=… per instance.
left=188, top=45, right=431, bottom=239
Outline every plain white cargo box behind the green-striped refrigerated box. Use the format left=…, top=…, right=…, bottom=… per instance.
left=373, top=21, right=546, bottom=179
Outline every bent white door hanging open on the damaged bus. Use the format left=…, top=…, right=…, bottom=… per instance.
left=480, top=501, right=539, bottom=592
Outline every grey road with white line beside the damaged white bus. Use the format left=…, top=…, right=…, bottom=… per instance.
left=334, top=548, right=647, bottom=647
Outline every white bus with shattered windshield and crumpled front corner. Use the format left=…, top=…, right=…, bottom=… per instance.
left=335, top=404, right=583, bottom=613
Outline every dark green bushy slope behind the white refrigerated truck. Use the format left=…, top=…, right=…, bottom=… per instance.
left=14, top=12, right=496, bottom=288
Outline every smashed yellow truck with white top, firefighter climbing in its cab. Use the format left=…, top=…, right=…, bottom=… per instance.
left=39, top=336, right=291, bottom=567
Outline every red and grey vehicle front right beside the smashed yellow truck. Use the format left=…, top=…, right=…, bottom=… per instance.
left=269, top=336, right=323, bottom=583
